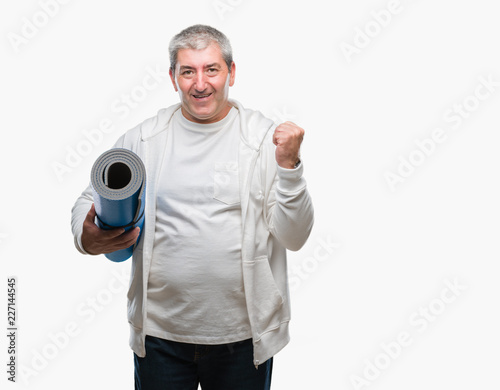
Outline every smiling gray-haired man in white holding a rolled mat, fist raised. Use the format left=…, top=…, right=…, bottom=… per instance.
left=72, top=25, right=313, bottom=390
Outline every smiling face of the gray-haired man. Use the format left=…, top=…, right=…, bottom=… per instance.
left=170, top=44, right=235, bottom=123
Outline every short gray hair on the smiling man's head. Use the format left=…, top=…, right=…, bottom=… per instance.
left=168, top=24, right=233, bottom=73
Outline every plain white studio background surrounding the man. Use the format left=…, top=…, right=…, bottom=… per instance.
left=0, top=0, right=500, bottom=390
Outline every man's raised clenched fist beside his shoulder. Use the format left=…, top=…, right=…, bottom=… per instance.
left=273, top=122, right=304, bottom=169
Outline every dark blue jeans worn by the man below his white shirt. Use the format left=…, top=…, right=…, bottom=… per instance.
left=134, top=336, right=273, bottom=390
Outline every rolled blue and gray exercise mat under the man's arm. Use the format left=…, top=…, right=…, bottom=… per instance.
left=90, top=148, right=146, bottom=262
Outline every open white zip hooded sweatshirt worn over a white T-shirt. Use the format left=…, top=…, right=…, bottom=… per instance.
left=71, top=100, right=314, bottom=366
